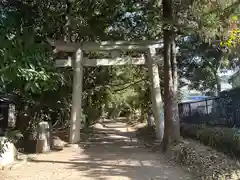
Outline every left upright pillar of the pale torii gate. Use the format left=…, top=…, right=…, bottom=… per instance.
left=69, top=49, right=83, bottom=144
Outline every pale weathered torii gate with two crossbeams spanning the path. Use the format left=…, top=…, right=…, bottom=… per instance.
left=48, top=39, right=164, bottom=144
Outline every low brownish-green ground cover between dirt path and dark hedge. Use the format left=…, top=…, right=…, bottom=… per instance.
left=171, top=140, right=240, bottom=180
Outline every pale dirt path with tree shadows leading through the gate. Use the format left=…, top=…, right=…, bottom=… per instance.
left=0, top=121, right=191, bottom=180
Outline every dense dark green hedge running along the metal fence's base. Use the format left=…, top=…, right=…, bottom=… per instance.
left=181, top=123, right=240, bottom=157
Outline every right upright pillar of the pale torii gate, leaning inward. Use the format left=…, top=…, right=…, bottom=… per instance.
left=145, top=48, right=164, bottom=142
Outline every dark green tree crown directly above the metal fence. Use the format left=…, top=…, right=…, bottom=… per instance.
left=178, top=36, right=238, bottom=91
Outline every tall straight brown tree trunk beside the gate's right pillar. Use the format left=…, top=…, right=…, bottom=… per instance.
left=163, top=0, right=180, bottom=151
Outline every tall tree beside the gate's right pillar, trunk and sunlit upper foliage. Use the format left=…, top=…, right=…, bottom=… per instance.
left=162, top=0, right=240, bottom=150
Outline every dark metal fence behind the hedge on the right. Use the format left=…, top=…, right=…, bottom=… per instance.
left=178, top=94, right=240, bottom=127
